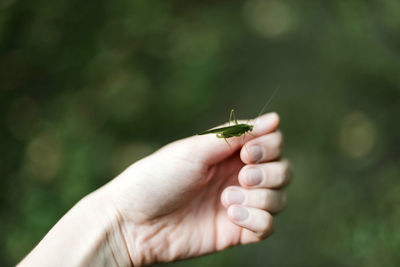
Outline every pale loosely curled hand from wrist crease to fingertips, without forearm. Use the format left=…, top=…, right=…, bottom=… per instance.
left=98, top=113, right=290, bottom=266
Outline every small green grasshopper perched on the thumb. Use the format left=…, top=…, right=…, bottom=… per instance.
left=198, top=109, right=254, bottom=147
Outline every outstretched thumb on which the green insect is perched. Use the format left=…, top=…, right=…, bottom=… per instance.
left=163, top=113, right=279, bottom=164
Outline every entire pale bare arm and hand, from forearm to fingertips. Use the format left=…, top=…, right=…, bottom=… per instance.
left=19, top=113, right=291, bottom=266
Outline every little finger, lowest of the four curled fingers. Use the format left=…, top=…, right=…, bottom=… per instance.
left=228, top=205, right=273, bottom=238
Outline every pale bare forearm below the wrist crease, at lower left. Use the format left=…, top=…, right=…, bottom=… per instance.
left=19, top=192, right=131, bottom=266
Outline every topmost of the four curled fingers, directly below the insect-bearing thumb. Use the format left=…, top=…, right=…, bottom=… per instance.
left=240, top=131, right=283, bottom=164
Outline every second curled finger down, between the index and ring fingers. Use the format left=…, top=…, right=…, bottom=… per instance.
left=238, top=160, right=293, bottom=188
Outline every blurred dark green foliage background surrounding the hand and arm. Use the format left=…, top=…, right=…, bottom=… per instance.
left=0, top=0, right=400, bottom=266
